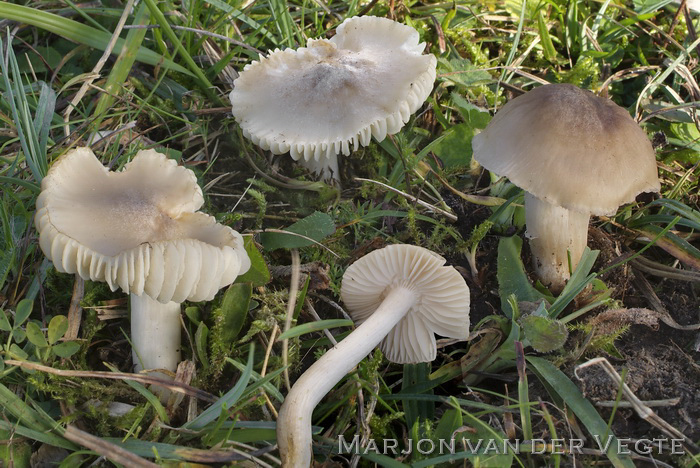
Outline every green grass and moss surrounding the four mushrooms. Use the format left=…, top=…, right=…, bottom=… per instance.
left=0, top=0, right=700, bottom=467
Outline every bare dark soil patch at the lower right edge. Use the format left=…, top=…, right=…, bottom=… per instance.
left=579, top=278, right=700, bottom=441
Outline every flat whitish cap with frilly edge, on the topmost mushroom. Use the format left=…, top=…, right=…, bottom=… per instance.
left=230, top=16, right=437, bottom=165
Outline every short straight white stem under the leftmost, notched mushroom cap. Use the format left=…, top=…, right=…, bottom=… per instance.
left=130, top=294, right=180, bottom=376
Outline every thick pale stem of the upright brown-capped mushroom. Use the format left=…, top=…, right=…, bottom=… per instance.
left=525, top=192, right=591, bottom=293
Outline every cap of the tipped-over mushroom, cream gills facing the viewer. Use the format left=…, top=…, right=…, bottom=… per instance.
left=340, top=244, right=469, bottom=364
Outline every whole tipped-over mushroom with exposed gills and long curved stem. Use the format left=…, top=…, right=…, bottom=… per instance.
left=277, top=245, right=469, bottom=468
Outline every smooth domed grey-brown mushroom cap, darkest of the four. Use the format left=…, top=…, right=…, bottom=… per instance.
left=472, top=84, right=661, bottom=215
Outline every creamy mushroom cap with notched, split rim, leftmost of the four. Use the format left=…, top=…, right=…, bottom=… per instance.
left=34, top=148, right=250, bottom=303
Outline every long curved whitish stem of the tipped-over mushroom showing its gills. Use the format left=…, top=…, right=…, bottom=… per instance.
left=277, top=287, right=418, bottom=468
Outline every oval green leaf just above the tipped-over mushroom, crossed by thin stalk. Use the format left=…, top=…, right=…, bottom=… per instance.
left=260, top=211, right=335, bottom=250
